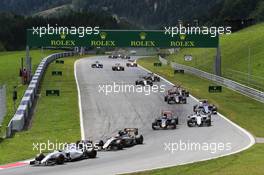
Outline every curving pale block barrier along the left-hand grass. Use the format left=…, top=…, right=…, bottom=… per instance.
left=6, top=52, right=74, bottom=137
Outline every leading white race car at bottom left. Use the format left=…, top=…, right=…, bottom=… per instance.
left=30, top=143, right=97, bottom=166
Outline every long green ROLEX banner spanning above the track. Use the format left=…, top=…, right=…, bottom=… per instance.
left=27, top=30, right=219, bottom=48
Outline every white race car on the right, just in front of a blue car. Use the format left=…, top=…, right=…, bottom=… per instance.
left=187, top=111, right=211, bottom=127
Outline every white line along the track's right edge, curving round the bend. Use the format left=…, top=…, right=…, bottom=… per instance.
left=122, top=65, right=255, bottom=174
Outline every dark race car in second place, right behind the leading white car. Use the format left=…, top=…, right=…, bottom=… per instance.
left=98, top=128, right=144, bottom=150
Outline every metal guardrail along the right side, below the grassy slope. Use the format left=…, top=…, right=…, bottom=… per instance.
left=159, top=57, right=264, bottom=103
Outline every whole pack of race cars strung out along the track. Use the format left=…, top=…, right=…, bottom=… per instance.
left=30, top=55, right=217, bottom=166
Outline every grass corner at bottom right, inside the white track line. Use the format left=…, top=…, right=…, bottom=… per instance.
left=127, top=144, right=264, bottom=175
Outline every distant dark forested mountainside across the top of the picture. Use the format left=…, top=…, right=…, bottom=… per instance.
left=0, top=0, right=264, bottom=29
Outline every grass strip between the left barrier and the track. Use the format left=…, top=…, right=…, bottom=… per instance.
left=0, top=57, right=80, bottom=164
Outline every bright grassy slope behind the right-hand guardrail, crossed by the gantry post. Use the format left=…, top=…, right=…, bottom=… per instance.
left=169, top=23, right=264, bottom=90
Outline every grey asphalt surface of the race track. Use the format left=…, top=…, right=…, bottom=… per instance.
left=3, top=56, right=251, bottom=175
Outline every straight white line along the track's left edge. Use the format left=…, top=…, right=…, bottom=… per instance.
left=74, top=60, right=85, bottom=140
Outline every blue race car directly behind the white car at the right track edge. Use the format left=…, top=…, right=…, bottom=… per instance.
left=193, top=99, right=217, bottom=114
